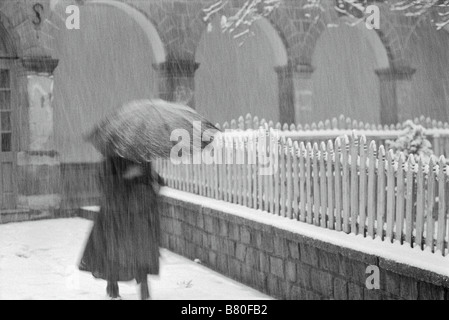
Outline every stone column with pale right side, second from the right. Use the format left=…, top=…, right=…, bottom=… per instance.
left=275, top=63, right=313, bottom=124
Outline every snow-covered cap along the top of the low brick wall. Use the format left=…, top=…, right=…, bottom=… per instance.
left=161, top=188, right=449, bottom=285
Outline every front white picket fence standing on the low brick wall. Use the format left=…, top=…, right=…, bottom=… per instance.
left=156, top=130, right=449, bottom=256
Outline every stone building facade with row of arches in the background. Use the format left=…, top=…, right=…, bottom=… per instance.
left=0, top=0, right=449, bottom=213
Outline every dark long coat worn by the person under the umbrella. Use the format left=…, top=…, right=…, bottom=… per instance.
left=79, top=161, right=160, bottom=283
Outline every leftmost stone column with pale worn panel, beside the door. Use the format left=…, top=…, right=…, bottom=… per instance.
left=17, top=56, right=61, bottom=214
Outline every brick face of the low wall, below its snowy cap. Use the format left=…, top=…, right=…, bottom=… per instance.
left=162, top=196, right=449, bottom=300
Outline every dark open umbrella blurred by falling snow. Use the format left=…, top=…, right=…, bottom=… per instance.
left=85, top=99, right=219, bottom=162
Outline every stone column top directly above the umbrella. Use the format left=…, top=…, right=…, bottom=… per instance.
left=153, top=58, right=200, bottom=108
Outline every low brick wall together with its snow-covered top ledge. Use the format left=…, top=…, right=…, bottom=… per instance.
left=161, top=188, right=449, bottom=299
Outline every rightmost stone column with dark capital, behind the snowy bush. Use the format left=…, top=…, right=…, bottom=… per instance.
left=375, top=67, right=416, bottom=124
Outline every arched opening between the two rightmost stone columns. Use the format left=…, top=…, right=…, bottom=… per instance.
left=311, top=19, right=389, bottom=123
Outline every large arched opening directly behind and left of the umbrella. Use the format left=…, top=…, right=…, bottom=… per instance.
left=53, top=0, right=166, bottom=163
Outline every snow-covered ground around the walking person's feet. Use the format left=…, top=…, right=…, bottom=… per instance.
left=0, top=219, right=270, bottom=300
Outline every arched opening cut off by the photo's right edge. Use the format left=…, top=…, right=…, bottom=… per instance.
left=404, top=25, right=449, bottom=121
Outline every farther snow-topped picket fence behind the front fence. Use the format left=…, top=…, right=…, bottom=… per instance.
left=217, top=114, right=449, bottom=158
